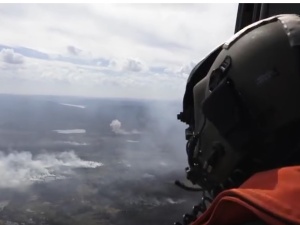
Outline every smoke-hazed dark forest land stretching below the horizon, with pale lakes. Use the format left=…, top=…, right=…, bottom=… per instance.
left=0, top=95, right=200, bottom=225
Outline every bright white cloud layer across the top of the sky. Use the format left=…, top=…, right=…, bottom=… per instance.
left=0, top=4, right=237, bottom=63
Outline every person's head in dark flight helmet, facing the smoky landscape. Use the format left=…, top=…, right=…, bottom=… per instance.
left=178, top=15, right=300, bottom=193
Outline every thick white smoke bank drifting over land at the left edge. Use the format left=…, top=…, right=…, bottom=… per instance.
left=0, top=151, right=103, bottom=188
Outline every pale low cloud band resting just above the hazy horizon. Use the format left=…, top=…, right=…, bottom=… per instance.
left=0, top=55, right=186, bottom=99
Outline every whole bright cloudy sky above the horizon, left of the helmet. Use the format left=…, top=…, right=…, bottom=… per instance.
left=0, top=3, right=238, bottom=99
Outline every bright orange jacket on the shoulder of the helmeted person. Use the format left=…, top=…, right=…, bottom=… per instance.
left=193, top=166, right=300, bottom=225
